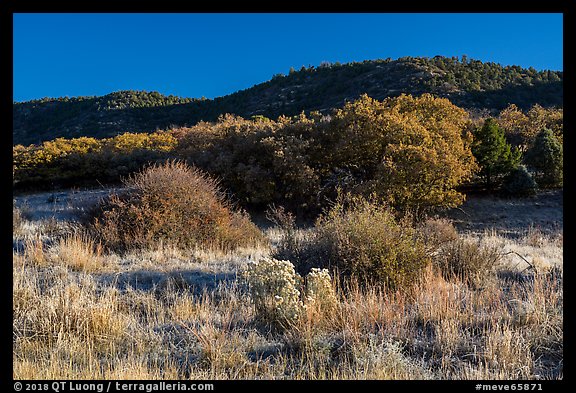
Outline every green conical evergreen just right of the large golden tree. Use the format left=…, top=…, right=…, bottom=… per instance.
left=472, top=118, right=522, bottom=189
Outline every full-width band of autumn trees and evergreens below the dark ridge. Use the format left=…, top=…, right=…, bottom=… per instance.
left=13, top=94, right=562, bottom=219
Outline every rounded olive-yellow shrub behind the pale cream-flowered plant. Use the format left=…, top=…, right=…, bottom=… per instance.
left=299, top=197, right=430, bottom=289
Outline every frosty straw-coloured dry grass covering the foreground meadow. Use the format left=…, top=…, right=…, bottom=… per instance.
left=13, top=205, right=563, bottom=380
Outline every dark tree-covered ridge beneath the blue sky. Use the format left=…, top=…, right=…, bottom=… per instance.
left=13, top=56, right=563, bottom=145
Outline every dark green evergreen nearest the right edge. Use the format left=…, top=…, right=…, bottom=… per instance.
left=525, top=128, right=563, bottom=187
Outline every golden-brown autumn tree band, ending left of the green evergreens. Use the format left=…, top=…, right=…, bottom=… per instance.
left=14, top=95, right=476, bottom=211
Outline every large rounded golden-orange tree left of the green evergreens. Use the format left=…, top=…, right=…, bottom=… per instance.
left=318, top=94, right=477, bottom=214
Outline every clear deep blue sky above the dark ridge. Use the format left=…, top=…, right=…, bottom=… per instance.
left=13, top=13, right=563, bottom=101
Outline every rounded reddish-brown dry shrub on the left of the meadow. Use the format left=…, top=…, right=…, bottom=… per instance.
left=92, top=161, right=263, bottom=251
